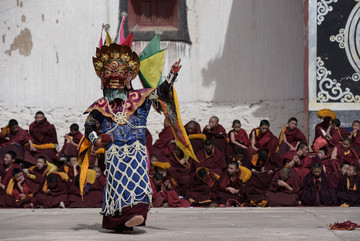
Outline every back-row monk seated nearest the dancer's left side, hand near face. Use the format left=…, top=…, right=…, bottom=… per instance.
left=58, top=123, right=83, bottom=159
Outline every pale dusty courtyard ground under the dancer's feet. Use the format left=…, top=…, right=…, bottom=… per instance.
left=0, top=207, right=360, bottom=241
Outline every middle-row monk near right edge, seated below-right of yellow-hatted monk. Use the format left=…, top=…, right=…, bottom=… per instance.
left=330, top=137, right=359, bottom=169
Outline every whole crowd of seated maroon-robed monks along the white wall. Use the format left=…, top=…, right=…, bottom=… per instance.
left=0, top=111, right=360, bottom=208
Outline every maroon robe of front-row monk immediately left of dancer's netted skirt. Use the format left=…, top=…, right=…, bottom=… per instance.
left=69, top=175, right=106, bottom=208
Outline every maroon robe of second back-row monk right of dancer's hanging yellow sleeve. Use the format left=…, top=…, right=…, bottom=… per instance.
left=203, top=124, right=227, bottom=160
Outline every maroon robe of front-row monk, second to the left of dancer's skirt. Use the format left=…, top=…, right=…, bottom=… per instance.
left=35, top=173, right=70, bottom=208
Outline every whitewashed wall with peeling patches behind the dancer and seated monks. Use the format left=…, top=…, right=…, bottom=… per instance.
left=0, top=0, right=304, bottom=141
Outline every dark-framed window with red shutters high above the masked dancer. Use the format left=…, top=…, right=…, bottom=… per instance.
left=119, top=0, right=191, bottom=43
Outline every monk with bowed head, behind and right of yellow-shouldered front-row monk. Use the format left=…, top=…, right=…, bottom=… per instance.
left=244, top=149, right=283, bottom=201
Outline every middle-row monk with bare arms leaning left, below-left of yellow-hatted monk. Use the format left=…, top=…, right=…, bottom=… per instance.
left=282, top=143, right=312, bottom=181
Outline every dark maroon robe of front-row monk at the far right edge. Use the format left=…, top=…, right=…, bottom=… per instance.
left=336, top=176, right=360, bottom=206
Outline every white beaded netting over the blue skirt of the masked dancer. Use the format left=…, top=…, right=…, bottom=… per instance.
left=102, top=140, right=152, bottom=215
